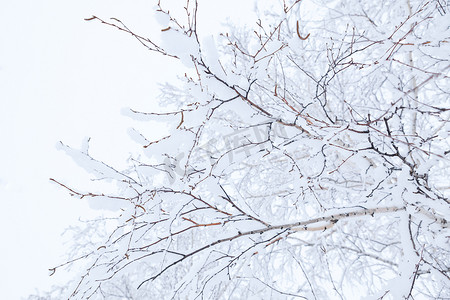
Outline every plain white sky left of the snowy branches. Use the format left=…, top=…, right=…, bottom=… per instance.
left=0, top=0, right=253, bottom=300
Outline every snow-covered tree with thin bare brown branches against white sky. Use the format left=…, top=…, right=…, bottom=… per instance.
left=39, top=0, right=450, bottom=299
